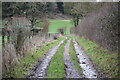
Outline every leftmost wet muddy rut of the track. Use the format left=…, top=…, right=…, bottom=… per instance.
left=29, top=40, right=64, bottom=78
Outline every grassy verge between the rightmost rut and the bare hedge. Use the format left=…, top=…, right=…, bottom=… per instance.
left=76, top=37, right=118, bottom=78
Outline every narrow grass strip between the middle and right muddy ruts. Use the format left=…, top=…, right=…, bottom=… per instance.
left=69, top=41, right=82, bottom=75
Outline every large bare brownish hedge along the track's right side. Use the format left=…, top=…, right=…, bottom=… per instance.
left=74, top=3, right=119, bottom=51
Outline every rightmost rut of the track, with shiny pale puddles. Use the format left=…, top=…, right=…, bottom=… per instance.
left=73, top=39, right=99, bottom=78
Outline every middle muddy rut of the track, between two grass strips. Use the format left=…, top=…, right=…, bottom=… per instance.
left=64, top=40, right=81, bottom=78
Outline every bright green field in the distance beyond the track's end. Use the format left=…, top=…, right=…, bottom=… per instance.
left=49, top=20, right=74, bottom=34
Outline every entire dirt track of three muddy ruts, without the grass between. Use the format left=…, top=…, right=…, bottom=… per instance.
left=29, top=37, right=104, bottom=78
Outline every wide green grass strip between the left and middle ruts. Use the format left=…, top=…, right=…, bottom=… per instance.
left=47, top=40, right=67, bottom=78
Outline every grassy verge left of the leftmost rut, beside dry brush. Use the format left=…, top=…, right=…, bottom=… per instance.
left=3, top=37, right=65, bottom=78
